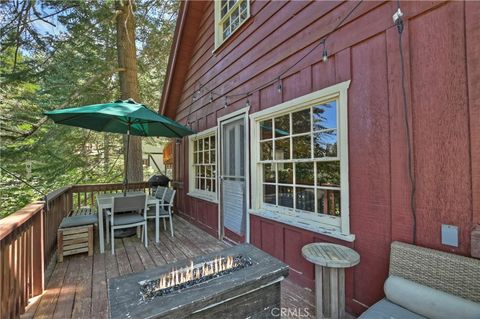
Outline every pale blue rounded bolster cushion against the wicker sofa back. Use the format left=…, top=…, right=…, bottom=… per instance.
left=384, top=276, right=480, bottom=319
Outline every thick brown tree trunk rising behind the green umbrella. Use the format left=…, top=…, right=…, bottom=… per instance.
left=115, top=0, right=143, bottom=182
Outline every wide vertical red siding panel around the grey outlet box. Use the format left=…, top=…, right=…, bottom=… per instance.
left=410, top=3, right=472, bottom=254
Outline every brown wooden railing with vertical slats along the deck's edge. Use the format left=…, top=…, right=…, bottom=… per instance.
left=0, top=182, right=149, bottom=319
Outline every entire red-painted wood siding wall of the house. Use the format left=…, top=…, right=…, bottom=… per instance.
left=170, top=1, right=480, bottom=314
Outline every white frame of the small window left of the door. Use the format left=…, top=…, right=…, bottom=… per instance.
left=187, top=126, right=218, bottom=203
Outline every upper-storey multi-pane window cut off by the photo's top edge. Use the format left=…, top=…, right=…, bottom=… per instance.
left=215, top=0, right=250, bottom=47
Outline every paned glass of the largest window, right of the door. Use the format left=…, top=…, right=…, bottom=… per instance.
left=259, top=99, right=341, bottom=226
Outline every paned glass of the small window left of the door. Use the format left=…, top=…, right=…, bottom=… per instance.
left=192, top=134, right=217, bottom=193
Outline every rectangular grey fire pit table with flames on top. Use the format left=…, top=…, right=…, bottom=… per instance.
left=108, top=244, right=288, bottom=318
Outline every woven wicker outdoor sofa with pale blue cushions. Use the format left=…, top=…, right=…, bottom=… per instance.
left=358, top=242, right=480, bottom=319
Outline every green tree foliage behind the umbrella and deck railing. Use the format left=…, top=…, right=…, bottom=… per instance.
left=0, top=0, right=178, bottom=217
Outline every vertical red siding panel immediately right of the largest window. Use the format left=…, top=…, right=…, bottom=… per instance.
left=348, top=33, right=391, bottom=305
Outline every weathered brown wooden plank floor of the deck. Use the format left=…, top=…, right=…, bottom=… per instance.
left=22, top=216, right=315, bottom=318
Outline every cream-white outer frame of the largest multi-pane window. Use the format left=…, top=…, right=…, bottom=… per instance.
left=250, top=81, right=355, bottom=241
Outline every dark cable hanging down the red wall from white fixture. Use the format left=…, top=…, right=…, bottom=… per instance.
left=393, top=0, right=417, bottom=244
